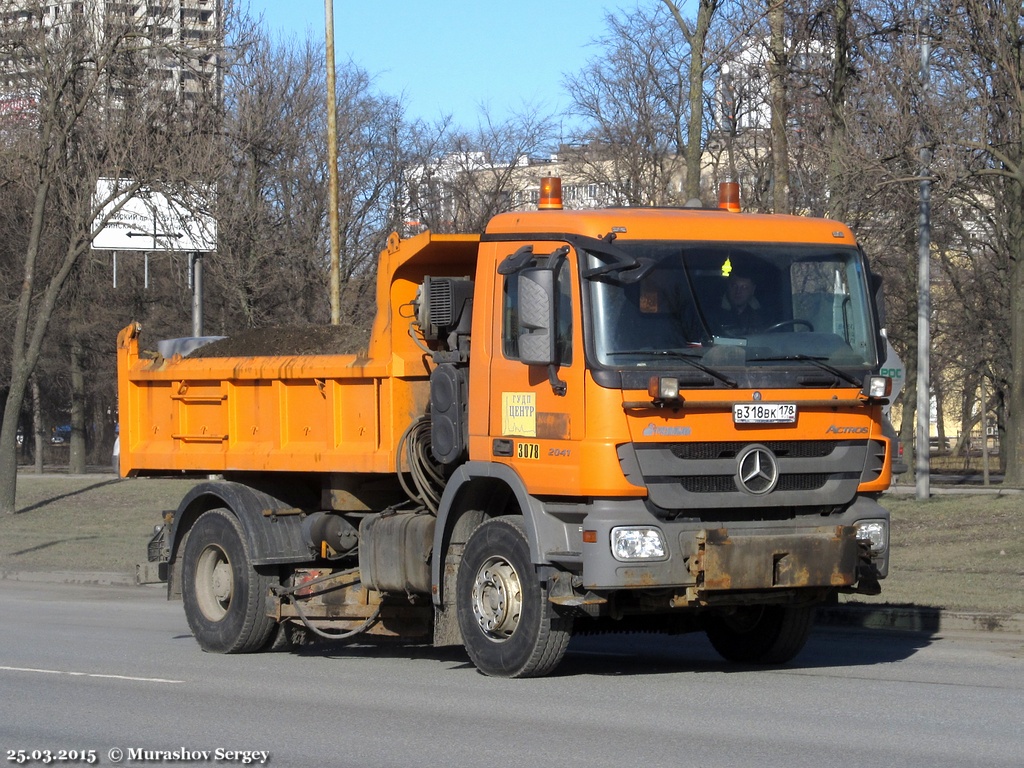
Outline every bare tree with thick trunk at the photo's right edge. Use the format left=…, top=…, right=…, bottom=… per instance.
left=932, top=0, right=1024, bottom=485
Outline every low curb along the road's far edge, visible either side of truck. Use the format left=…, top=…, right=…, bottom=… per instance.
left=0, top=570, right=1024, bottom=635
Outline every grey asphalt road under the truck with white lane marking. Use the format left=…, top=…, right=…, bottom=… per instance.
left=0, top=581, right=1024, bottom=768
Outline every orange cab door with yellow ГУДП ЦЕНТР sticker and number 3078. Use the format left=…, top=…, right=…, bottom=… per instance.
left=488, top=243, right=586, bottom=494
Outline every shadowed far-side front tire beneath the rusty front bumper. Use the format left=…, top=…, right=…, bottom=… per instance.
left=706, top=605, right=814, bottom=665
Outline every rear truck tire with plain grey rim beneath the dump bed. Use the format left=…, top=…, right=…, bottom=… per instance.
left=181, top=509, right=275, bottom=653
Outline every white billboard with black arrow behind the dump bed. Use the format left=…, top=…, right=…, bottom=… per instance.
left=92, top=178, right=217, bottom=252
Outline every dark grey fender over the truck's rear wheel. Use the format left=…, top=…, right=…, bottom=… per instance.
left=168, top=480, right=314, bottom=565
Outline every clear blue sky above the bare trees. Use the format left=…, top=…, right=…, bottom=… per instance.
left=243, top=0, right=634, bottom=127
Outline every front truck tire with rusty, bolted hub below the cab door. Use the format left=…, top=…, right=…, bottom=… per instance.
left=456, top=517, right=572, bottom=678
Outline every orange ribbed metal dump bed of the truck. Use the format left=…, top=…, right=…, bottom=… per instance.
left=118, top=232, right=479, bottom=476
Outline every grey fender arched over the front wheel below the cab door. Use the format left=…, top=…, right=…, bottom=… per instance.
left=430, top=462, right=583, bottom=606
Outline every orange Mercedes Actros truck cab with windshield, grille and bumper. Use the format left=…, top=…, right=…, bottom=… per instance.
left=415, top=189, right=892, bottom=665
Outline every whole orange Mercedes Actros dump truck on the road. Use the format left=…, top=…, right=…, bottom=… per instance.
left=118, top=182, right=893, bottom=677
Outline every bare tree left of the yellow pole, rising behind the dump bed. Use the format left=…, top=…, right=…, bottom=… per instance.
left=208, top=31, right=328, bottom=327
